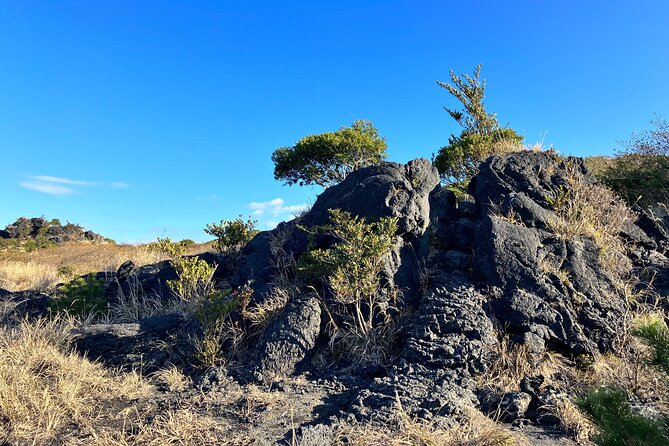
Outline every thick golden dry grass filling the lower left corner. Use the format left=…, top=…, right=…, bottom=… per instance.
left=0, top=320, right=149, bottom=445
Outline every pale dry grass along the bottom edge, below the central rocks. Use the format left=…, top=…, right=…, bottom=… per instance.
left=335, top=406, right=529, bottom=446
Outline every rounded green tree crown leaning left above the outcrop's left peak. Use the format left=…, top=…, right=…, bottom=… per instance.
left=272, top=120, right=387, bottom=187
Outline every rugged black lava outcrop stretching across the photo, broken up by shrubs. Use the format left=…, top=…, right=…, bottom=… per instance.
left=11, top=152, right=669, bottom=438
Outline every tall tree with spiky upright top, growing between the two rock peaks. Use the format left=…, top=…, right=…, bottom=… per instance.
left=433, top=65, right=523, bottom=190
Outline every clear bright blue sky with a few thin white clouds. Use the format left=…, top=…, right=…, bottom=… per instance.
left=0, top=0, right=669, bottom=242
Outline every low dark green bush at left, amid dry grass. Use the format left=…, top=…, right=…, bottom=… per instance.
left=49, top=273, right=108, bottom=317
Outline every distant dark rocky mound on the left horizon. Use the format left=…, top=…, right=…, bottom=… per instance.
left=0, top=217, right=105, bottom=243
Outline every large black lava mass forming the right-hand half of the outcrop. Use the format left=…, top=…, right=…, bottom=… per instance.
left=471, top=152, right=625, bottom=355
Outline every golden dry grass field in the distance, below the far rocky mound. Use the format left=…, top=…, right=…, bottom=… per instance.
left=0, top=243, right=211, bottom=291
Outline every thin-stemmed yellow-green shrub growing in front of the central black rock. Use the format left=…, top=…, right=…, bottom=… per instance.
left=298, top=209, right=397, bottom=362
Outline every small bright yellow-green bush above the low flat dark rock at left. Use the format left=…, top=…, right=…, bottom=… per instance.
left=167, top=257, right=216, bottom=301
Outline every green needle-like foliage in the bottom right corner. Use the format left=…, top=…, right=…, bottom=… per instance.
left=576, top=387, right=669, bottom=446
